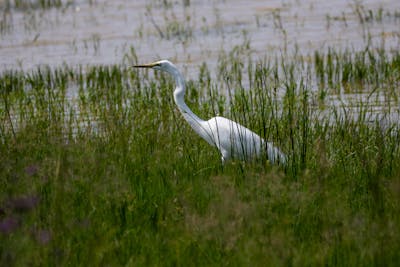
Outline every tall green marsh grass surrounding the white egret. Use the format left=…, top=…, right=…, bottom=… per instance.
left=0, top=47, right=400, bottom=266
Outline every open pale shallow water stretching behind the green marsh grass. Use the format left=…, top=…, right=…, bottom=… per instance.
left=0, top=0, right=400, bottom=75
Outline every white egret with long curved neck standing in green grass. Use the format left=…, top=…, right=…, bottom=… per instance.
left=134, top=60, right=286, bottom=164
